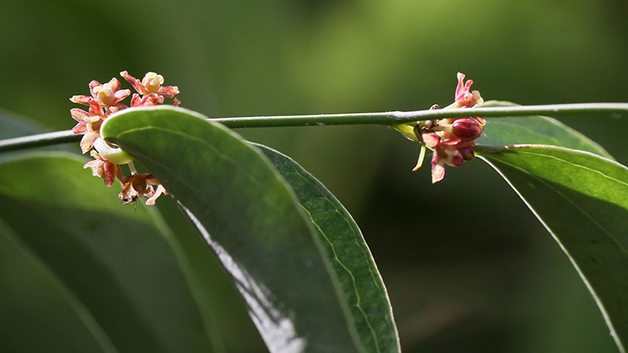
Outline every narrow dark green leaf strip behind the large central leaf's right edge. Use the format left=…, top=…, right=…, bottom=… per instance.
left=256, top=145, right=400, bottom=352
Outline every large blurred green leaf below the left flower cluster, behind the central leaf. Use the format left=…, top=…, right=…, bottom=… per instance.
left=0, top=153, right=218, bottom=352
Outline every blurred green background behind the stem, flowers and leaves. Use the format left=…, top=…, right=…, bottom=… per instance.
left=0, top=0, right=628, bottom=352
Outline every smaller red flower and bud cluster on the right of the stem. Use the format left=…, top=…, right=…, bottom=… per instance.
left=402, top=72, right=486, bottom=183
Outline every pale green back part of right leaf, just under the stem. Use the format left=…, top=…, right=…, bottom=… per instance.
left=477, top=101, right=613, bottom=159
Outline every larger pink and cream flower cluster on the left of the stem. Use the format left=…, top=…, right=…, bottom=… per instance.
left=70, top=71, right=180, bottom=205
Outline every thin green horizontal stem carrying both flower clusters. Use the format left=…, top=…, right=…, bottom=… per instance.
left=0, top=103, right=628, bottom=152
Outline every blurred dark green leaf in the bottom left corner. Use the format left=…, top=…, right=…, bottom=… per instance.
left=0, top=216, right=115, bottom=352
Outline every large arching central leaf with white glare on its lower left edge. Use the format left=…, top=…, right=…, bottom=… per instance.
left=101, top=106, right=365, bottom=353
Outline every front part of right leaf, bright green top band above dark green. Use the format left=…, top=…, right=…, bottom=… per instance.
left=479, top=145, right=628, bottom=352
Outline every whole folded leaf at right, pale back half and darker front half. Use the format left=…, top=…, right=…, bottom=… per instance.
left=477, top=101, right=628, bottom=352
